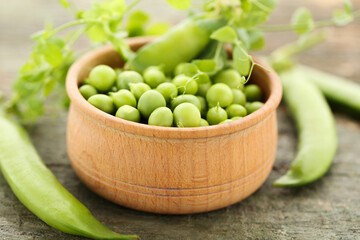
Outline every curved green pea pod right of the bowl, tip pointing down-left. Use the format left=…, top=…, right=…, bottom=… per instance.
left=273, top=69, right=337, bottom=187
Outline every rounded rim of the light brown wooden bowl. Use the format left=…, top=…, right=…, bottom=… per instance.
left=66, top=37, right=282, bottom=139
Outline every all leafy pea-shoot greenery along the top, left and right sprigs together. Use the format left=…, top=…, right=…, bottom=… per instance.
left=5, top=0, right=360, bottom=124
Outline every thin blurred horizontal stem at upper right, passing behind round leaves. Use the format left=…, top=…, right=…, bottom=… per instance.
left=259, top=10, right=360, bottom=32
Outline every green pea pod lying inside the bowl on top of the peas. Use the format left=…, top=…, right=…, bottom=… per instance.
left=126, top=19, right=225, bottom=74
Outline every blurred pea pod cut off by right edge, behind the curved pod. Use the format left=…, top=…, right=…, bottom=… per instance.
left=299, top=66, right=360, bottom=117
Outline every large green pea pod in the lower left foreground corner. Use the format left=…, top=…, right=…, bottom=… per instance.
left=0, top=107, right=138, bottom=239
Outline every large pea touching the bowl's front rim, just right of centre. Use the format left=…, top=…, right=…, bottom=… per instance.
left=174, top=103, right=201, bottom=127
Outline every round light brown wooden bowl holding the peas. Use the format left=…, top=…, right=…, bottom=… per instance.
left=66, top=38, right=282, bottom=214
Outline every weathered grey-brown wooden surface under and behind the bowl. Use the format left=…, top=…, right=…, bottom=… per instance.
left=0, top=0, right=360, bottom=239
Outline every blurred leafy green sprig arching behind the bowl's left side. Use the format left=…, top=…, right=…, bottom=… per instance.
left=6, top=0, right=176, bottom=124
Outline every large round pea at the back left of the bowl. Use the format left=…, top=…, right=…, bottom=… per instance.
left=86, top=65, right=116, bottom=92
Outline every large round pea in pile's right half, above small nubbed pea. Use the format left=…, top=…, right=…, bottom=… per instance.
left=206, top=83, right=234, bottom=107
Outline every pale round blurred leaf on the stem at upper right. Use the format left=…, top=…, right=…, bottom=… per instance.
left=291, top=8, right=315, bottom=35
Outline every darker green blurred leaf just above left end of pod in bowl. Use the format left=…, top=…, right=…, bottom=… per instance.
left=127, top=11, right=150, bottom=37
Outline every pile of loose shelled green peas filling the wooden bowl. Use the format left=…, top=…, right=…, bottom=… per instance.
left=79, top=63, right=263, bottom=127
